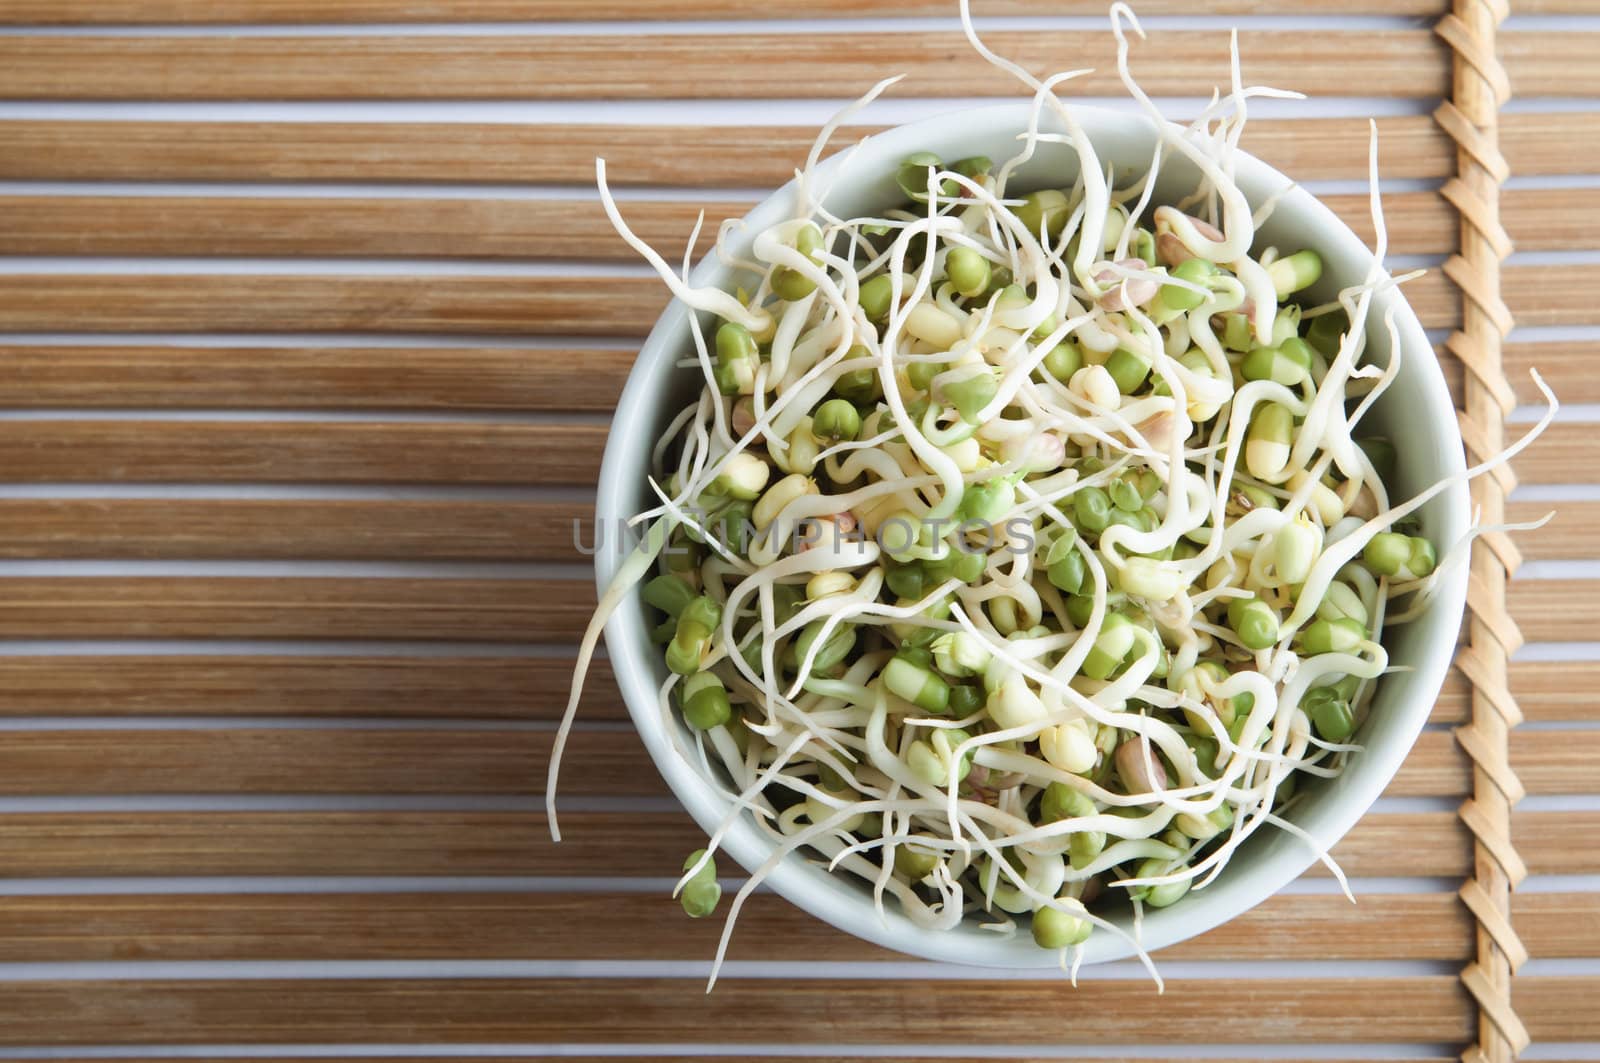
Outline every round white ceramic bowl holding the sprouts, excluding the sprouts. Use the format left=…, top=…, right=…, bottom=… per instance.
left=595, top=104, right=1469, bottom=967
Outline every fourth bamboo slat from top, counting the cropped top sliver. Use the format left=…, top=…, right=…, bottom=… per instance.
left=0, top=189, right=1600, bottom=263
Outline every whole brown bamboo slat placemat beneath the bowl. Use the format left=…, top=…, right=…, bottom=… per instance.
left=0, top=0, right=1600, bottom=1061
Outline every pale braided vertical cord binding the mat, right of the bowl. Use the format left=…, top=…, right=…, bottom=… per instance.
left=1434, top=0, right=1528, bottom=1063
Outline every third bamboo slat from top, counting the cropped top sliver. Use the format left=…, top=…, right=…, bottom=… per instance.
left=0, top=114, right=1459, bottom=189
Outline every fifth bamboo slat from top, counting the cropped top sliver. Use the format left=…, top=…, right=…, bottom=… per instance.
left=0, top=264, right=1600, bottom=336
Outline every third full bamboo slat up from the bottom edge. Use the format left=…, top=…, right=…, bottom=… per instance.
left=0, top=810, right=1580, bottom=877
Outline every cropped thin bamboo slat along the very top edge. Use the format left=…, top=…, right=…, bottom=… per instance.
left=0, top=0, right=1459, bottom=26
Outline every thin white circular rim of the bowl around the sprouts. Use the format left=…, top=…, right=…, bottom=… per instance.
left=595, top=102, right=1470, bottom=969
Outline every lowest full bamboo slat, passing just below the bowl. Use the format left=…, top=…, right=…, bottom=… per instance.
left=0, top=975, right=1472, bottom=1049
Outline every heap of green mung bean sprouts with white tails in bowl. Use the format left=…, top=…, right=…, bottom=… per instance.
left=549, top=2, right=1555, bottom=977
